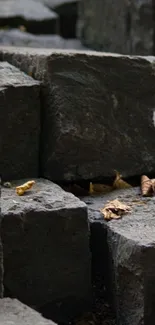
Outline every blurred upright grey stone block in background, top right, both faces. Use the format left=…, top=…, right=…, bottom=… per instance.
left=77, top=0, right=154, bottom=55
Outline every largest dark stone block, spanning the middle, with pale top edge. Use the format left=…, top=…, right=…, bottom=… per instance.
left=0, top=47, right=155, bottom=181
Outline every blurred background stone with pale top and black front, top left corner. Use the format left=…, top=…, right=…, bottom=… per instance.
left=0, top=0, right=59, bottom=34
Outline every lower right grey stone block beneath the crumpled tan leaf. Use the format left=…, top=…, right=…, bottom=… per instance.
left=83, top=188, right=155, bottom=325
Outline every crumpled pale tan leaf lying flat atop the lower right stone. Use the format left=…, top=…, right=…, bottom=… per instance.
left=100, top=199, right=131, bottom=220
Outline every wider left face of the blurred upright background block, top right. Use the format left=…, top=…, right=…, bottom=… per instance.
left=77, top=0, right=130, bottom=54
